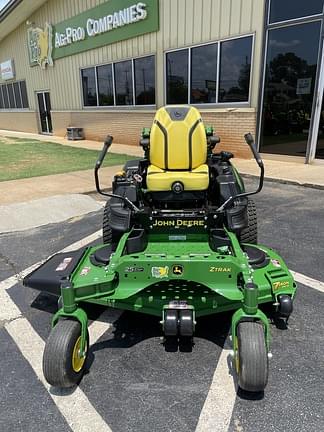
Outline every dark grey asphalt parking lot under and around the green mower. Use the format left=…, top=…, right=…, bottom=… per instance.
left=0, top=180, right=324, bottom=432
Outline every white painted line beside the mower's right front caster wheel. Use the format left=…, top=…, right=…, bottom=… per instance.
left=196, top=336, right=237, bottom=432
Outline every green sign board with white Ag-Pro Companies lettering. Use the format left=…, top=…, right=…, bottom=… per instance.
left=53, top=0, right=159, bottom=59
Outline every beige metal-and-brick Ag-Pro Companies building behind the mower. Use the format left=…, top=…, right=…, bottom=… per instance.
left=0, top=0, right=324, bottom=161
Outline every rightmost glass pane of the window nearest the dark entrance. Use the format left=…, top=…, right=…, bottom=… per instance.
left=218, top=36, right=252, bottom=102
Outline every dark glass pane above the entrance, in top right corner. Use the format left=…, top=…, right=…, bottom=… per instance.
left=269, top=0, right=323, bottom=23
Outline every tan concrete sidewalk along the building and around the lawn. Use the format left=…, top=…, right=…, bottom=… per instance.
left=0, top=130, right=324, bottom=205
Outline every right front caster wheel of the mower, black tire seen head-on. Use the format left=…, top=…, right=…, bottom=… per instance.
left=235, top=321, right=268, bottom=392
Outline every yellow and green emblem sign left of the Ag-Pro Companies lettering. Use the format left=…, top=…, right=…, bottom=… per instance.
left=28, top=23, right=53, bottom=69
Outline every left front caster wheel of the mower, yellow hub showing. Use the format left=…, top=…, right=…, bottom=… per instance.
left=43, top=320, right=89, bottom=387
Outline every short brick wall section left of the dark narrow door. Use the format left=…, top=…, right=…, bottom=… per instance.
left=0, top=111, right=38, bottom=133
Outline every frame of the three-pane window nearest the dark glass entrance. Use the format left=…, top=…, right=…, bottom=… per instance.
left=163, top=32, right=255, bottom=108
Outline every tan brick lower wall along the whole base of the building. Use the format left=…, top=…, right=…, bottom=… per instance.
left=0, top=110, right=256, bottom=158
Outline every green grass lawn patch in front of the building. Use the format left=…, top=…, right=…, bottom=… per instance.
left=0, top=136, right=136, bottom=181
